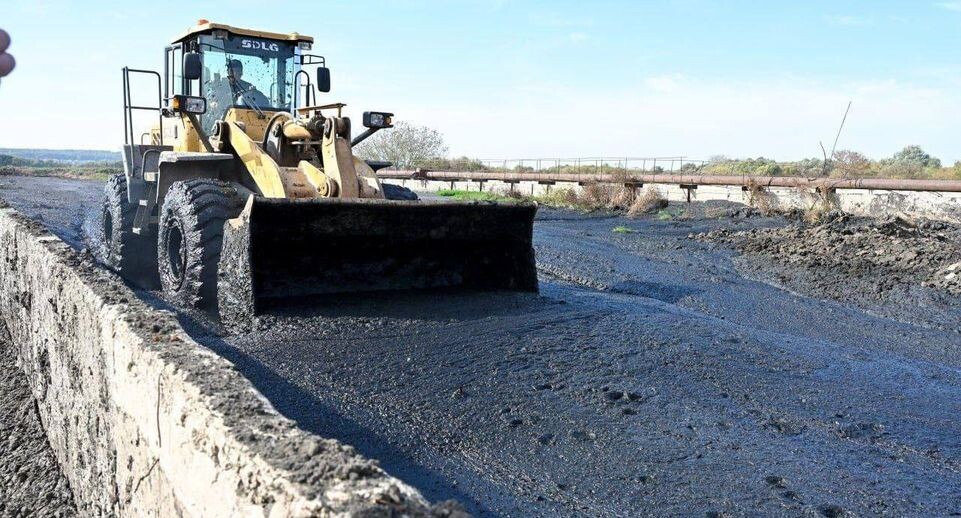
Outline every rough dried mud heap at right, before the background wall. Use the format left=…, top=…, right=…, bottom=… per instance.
left=689, top=212, right=961, bottom=324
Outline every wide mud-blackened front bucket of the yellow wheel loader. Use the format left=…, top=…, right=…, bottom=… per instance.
left=217, top=196, right=537, bottom=328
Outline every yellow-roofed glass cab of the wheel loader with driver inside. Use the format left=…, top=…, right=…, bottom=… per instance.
left=164, top=20, right=324, bottom=140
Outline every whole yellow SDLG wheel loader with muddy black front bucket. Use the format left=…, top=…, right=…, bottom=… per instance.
left=100, top=20, right=537, bottom=327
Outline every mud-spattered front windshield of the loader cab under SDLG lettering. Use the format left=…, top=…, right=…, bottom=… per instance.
left=199, top=34, right=296, bottom=131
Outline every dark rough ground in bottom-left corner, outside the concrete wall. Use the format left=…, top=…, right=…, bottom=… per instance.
left=0, top=328, right=77, bottom=517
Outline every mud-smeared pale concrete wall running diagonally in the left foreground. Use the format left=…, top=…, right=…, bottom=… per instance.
left=0, top=207, right=446, bottom=517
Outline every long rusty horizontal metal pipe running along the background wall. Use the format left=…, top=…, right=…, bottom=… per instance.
left=377, top=171, right=961, bottom=192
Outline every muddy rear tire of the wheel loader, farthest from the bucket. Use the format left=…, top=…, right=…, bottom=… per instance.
left=97, top=173, right=157, bottom=288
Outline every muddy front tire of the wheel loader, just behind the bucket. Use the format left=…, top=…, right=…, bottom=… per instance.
left=157, top=179, right=243, bottom=309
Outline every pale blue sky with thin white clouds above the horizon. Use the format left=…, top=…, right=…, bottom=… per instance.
left=0, top=0, right=961, bottom=162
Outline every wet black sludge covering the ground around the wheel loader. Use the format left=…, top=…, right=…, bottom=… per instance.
left=0, top=179, right=961, bottom=516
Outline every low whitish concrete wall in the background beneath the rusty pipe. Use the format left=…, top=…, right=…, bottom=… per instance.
left=386, top=180, right=961, bottom=222
